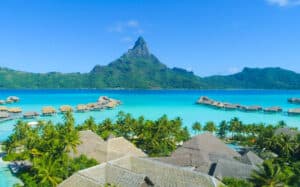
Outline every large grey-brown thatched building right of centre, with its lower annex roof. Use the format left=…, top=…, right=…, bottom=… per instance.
left=152, top=133, right=263, bottom=180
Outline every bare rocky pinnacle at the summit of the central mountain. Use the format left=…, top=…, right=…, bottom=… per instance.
left=126, top=36, right=151, bottom=57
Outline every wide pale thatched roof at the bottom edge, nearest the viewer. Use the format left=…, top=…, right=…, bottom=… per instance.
left=59, top=156, right=221, bottom=187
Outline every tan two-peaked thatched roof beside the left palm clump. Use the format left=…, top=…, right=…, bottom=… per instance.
left=71, top=130, right=146, bottom=163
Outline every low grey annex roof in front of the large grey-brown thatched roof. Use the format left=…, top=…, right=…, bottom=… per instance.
left=211, top=159, right=256, bottom=180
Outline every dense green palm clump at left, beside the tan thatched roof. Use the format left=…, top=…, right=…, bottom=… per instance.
left=4, top=113, right=97, bottom=187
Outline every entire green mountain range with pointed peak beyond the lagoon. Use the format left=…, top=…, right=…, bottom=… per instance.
left=0, top=37, right=300, bottom=89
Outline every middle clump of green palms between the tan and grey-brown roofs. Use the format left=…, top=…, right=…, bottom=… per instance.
left=77, top=112, right=190, bottom=156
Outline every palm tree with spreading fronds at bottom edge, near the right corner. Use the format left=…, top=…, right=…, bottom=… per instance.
left=250, top=160, right=287, bottom=187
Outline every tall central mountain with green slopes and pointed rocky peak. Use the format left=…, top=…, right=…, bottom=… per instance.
left=90, top=37, right=204, bottom=88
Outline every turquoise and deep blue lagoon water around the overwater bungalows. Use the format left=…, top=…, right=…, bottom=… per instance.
left=0, top=90, right=300, bottom=187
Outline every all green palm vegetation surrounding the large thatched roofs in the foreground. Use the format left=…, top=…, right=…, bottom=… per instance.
left=4, top=112, right=300, bottom=187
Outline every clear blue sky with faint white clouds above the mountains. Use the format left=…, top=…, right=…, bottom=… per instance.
left=0, top=0, right=300, bottom=76
